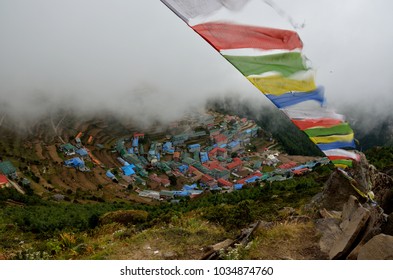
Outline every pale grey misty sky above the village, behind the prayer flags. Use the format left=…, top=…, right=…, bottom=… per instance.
left=0, top=0, right=393, bottom=124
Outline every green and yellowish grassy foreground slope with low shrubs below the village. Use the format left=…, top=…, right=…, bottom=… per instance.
left=0, top=164, right=330, bottom=259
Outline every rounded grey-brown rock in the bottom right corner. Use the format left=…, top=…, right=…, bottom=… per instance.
left=358, top=234, right=393, bottom=260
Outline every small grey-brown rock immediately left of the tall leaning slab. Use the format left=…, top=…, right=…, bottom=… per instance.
left=315, top=218, right=342, bottom=254
